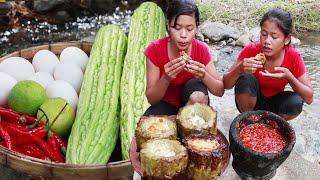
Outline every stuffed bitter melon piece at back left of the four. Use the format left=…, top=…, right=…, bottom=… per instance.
left=135, top=115, right=177, bottom=149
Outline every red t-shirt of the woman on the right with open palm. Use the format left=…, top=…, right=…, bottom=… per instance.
left=238, top=43, right=307, bottom=97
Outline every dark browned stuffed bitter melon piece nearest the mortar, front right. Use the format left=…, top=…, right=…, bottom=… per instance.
left=183, top=134, right=228, bottom=180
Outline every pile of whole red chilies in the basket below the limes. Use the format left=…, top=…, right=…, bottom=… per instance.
left=0, top=107, right=66, bottom=163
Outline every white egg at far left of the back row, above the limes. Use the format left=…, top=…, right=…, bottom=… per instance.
left=0, top=57, right=35, bottom=81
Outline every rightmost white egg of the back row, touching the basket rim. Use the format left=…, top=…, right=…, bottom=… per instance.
left=60, top=46, right=89, bottom=72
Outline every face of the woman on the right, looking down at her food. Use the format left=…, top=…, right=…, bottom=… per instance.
left=260, top=20, right=291, bottom=56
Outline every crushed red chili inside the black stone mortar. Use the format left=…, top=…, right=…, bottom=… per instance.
left=240, top=123, right=286, bottom=153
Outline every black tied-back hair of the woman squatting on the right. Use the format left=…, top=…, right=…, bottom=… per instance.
left=260, top=8, right=293, bottom=37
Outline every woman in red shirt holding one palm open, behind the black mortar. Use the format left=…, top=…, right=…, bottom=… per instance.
left=223, top=8, right=313, bottom=120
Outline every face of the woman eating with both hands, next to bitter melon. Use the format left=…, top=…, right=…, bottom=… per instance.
left=169, top=15, right=197, bottom=51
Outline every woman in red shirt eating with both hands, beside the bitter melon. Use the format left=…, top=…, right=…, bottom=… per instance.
left=144, top=0, right=224, bottom=116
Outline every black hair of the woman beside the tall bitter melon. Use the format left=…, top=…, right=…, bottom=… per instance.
left=166, top=0, right=200, bottom=28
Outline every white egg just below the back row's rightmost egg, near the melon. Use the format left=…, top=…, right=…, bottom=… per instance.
left=53, top=61, right=83, bottom=93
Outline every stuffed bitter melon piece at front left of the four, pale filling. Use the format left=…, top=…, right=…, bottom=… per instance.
left=140, top=139, right=188, bottom=179
